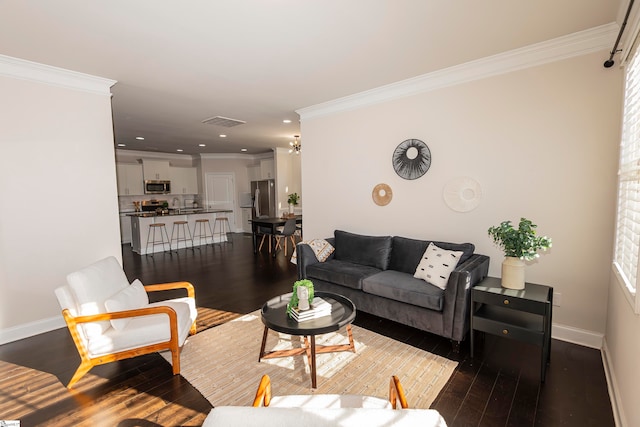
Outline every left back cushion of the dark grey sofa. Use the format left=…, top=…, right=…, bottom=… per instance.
left=334, top=230, right=391, bottom=270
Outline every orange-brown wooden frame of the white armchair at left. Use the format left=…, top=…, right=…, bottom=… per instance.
left=62, top=282, right=196, bottom=388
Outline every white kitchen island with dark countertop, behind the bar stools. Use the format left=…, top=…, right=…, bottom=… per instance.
left=127, top=209, right=233, bottom=255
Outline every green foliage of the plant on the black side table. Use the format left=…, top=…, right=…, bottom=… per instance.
left=488, top=218, right=551, bottom=261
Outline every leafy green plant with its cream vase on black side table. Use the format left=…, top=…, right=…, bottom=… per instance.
left=488, top=218, right=551, bottom=289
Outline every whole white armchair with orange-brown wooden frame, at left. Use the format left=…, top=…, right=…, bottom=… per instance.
left=55, top=257, right=197, bottom=388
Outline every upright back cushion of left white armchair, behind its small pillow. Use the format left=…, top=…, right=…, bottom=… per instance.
left=67, top=257, right=129, bottom=337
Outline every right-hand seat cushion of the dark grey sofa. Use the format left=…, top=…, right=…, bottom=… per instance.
left=362, top=270, right=444, bottom=311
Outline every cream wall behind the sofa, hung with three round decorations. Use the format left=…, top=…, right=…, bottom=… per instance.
left=301, top=52, right=622, bottom=347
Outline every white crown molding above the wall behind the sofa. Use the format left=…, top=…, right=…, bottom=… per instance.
left=296, top=23, right=619, bottom=121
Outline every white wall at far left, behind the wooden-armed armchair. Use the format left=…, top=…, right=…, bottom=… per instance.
left=0, top=57, right=121, bottom=343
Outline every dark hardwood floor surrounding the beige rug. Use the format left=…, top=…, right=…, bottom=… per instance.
left=0, top=234, right=614, bottom=427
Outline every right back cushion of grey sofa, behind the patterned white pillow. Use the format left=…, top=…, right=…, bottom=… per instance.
left=388, top=236, right=475, bottom=274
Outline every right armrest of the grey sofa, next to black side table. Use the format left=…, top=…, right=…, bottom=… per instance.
left=442, top=254, right=489, bottom=342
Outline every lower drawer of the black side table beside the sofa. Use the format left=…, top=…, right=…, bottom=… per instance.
left=473, top=305, right=545, bottom=345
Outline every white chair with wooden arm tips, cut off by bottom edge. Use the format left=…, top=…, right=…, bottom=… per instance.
left=202, top=375, right=447, bottom=427
